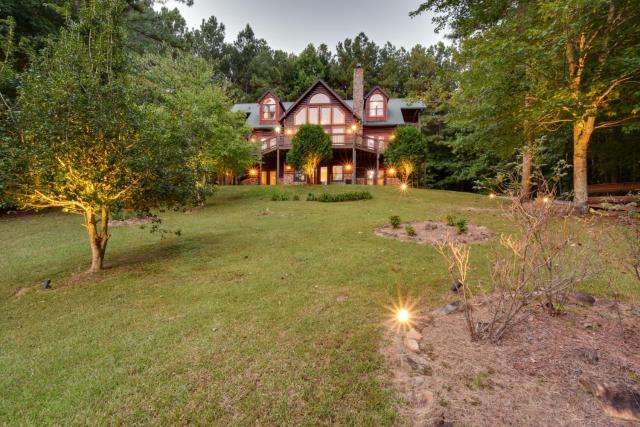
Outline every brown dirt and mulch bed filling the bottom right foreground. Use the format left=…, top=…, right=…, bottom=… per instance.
left=383, top=302, right=640, bottom=426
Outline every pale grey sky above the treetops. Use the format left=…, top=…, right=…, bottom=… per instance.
left=160, top=0, right=444, bottom=53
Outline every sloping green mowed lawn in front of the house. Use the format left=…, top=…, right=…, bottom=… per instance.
left=0, top=187, right=632, bottom=425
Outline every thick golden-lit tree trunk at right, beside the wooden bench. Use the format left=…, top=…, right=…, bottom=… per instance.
left=573, top=116, right=596, bottom=213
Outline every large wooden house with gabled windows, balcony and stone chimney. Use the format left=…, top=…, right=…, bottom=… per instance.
left=233, top=66, right=424, bottom=185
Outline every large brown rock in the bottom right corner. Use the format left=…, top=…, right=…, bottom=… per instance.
left=580, top=378, right=640, bottom=421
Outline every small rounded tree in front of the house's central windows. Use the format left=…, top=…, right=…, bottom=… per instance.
left=287, top=125, right=333, bottom=184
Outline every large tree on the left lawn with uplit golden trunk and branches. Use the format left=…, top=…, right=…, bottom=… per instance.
left=13, top=0, right=196, bottom=272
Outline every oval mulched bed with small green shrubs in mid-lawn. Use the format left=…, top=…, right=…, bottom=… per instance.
left=375, top=221, right=493, bottom=244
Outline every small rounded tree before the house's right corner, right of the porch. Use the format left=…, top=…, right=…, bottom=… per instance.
left=384, top=126, right=427, bottom=181
